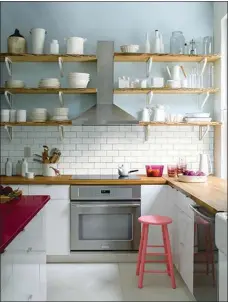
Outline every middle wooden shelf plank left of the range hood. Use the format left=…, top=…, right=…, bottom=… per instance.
left=0, top=88, right=97, bottom=94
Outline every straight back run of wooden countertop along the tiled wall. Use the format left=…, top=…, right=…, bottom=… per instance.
left=0, top=175, right=166, bottom=185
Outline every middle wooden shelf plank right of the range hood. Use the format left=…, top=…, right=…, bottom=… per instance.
left=114, top=88, right=219, bottom=94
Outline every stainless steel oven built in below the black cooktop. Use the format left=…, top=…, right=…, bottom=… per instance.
left=70, top=185, right=141, bottom=251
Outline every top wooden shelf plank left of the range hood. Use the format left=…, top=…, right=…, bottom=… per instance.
left=0, top=53, right=97, bottom=62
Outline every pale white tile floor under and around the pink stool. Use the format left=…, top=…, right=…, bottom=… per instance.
left=47, top=263, right=192, bottom=301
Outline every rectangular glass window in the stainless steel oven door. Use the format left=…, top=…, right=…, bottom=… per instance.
left=79, top=214, right=133, bottom=240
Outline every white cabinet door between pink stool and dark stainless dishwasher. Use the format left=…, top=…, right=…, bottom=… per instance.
left=178, top=210, right=194, bottom=294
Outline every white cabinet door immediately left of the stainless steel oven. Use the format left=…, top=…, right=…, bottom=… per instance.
left=46, top=199, right=70, bottom=255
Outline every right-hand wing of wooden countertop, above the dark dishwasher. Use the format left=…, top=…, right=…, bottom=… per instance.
left=164, top=176, right=227, bottom=213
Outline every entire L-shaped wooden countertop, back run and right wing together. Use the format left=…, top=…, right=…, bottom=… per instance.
left=0, top=175, right=227, bottom=213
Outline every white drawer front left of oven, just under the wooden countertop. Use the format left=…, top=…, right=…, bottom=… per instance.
left=29, top=185, right=70, bottom=199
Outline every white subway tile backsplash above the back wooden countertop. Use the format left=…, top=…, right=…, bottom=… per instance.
left=1, top=125, right=214, bottom=174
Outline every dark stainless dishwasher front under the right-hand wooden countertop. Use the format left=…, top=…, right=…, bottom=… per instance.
left=190, top=205, right=218, bottom=301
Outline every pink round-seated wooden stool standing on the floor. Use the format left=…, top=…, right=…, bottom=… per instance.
left=136, top=216, right=176, bottom=288
